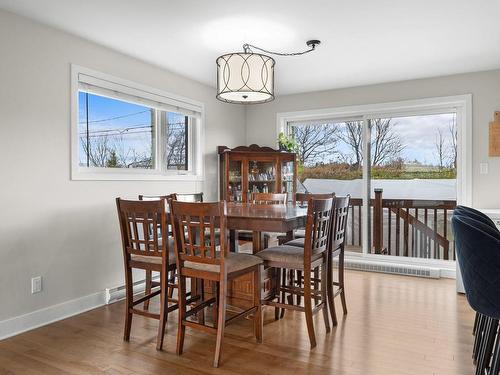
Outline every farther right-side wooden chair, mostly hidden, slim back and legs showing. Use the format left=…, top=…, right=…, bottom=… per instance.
left=327, top=195, right=351, bottom=326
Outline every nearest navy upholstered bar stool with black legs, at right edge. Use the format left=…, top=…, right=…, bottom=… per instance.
left=452, top=214, right=500, bottom=374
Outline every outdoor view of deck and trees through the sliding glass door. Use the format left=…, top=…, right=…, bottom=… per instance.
left=288, top=112, right=457, bottom=260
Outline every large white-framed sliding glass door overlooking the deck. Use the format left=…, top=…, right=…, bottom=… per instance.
left=277, top=95, right=471, bottom=269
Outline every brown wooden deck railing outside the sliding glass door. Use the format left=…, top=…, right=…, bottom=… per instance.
left=347, top=189, right=456, bottom=260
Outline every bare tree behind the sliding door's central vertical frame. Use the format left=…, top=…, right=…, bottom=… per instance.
left=340, top=119, right=405, bottom=167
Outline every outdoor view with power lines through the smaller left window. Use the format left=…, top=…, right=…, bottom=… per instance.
left=78, top=91, right=189, bottom=170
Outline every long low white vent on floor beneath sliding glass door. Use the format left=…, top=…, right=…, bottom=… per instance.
left=338, top=259, right=441, bottom=279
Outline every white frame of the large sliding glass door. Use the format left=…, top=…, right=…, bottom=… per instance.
left=276, top=94, right=472, bottom=277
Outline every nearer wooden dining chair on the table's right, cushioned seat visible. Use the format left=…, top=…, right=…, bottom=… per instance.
left=256, top=198, right=333, bottom=348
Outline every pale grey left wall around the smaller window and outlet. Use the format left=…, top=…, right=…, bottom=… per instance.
left=0, top=11, right=245, bottom=324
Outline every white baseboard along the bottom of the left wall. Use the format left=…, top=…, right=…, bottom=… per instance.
left=0, top=291, right=106, bottom=340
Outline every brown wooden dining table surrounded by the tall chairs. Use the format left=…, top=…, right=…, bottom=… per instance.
left=226, top=202, right=307, bottom=253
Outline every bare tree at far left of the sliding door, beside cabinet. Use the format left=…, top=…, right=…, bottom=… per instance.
left=293, top=124, right=340, bottom=165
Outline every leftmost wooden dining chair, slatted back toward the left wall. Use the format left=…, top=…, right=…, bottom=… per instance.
left=116, top=198, right=177, bottom=350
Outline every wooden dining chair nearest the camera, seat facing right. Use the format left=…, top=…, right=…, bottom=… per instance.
left=169, top=199, right=262, bottom=367
